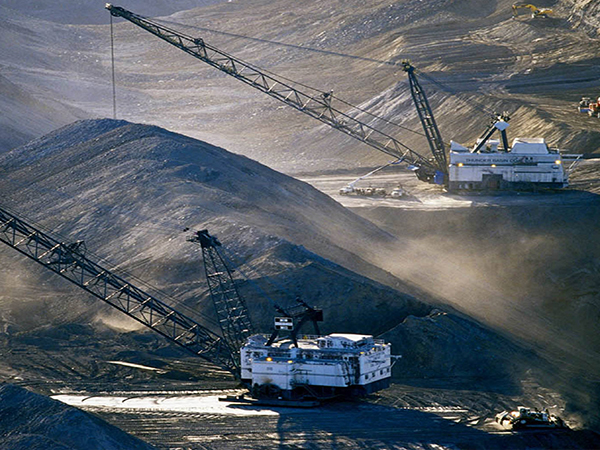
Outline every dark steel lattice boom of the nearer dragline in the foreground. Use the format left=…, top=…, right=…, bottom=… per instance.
left=0, top=208, right=239, bottom=376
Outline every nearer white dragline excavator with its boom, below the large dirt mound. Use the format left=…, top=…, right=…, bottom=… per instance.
left=0, top=208, right=392, bottom=406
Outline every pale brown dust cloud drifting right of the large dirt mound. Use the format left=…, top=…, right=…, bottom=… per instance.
left=364, top=210, right=597, bottom=351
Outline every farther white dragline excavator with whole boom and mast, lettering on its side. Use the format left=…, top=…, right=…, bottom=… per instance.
left=106, top=3, right=579, bottom=192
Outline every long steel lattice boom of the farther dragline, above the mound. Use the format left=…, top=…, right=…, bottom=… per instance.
left=106, top=3, right=445, bottom=181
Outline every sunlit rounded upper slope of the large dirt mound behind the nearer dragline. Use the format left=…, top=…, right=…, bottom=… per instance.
left=1, top=120, right=406, bottom=292
